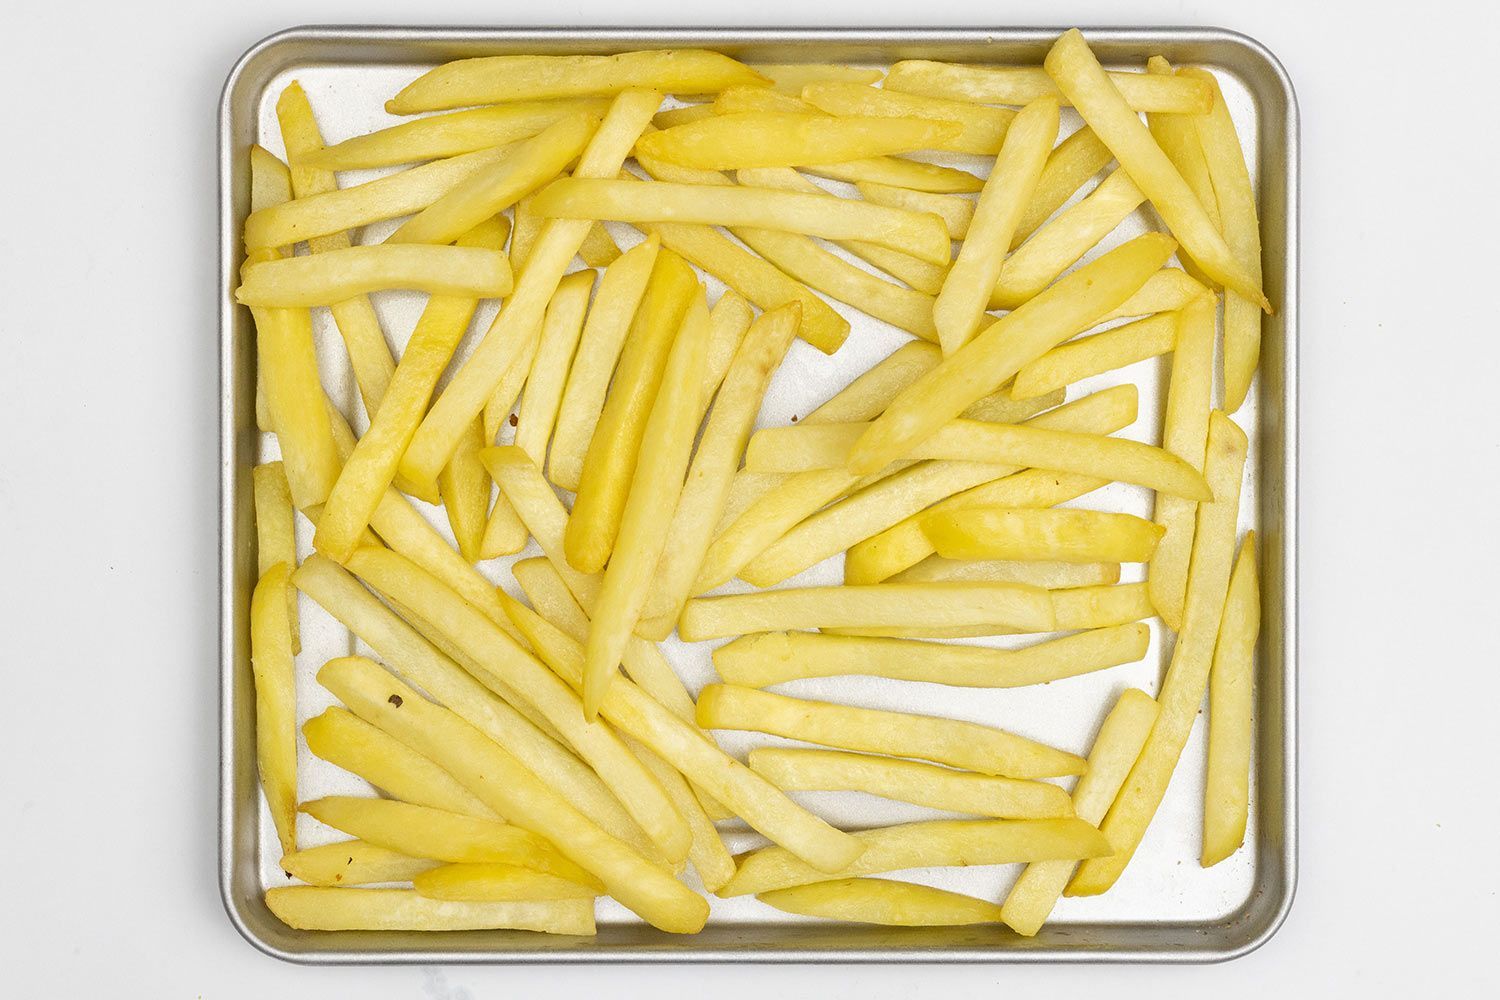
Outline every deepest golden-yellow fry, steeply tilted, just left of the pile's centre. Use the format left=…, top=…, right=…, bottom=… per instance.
left=564, top=252, right=708, bottom=573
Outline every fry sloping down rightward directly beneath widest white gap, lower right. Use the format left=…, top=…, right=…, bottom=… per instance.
left=698, top=684, right=1083, bottom=778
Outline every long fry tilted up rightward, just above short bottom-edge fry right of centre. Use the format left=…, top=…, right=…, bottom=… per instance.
left=719, top=819, right=1110, bottom=897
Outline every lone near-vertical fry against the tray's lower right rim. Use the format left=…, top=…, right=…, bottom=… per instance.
left=1202, top=532, right=1260, bottom=868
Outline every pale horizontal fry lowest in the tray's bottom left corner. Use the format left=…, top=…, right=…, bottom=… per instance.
left=266, top=886, right=594, bottom=936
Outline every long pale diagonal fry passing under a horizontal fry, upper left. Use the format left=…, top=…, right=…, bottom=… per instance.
left=401, top=90, right=662, bottom=494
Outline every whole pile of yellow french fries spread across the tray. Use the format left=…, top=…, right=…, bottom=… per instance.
left=236, top=30, right=1271, bottom=936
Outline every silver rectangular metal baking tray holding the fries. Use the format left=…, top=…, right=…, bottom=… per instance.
left=218, top=27, right=1298, bottom=964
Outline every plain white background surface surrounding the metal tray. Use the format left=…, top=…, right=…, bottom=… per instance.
left=0, top=0, right=1500, bottom=1000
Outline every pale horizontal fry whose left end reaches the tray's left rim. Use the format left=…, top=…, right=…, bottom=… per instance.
left=234, top=244, right=512, bottom=305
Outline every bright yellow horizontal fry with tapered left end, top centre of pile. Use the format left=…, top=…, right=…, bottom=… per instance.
left=639, top=113, right=963, bottom=169
